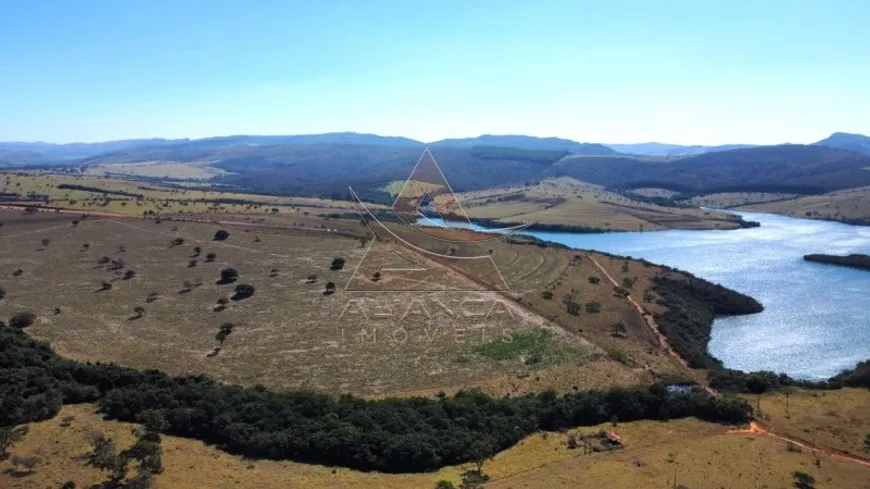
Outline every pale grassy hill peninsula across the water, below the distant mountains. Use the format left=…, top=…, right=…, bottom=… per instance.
left=442, top=178, right=739, bottom=231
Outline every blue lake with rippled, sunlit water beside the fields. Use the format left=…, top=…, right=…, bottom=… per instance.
left=430, top=212, right=870, bottom=379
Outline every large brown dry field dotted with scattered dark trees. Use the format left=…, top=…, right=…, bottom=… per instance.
left=0, top=201, right=700, bottom=396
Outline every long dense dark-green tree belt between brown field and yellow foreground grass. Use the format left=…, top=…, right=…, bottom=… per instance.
left=0, top=326, right=751, bottom=472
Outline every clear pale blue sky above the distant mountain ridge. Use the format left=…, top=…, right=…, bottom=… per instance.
left=0, top=0, right=870, bottom=144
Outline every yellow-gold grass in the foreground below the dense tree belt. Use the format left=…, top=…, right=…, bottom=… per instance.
left=0, top=405, right=870, bottom=489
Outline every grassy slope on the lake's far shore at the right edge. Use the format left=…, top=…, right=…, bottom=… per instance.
left=736, top=187, right=870, bottom=223
